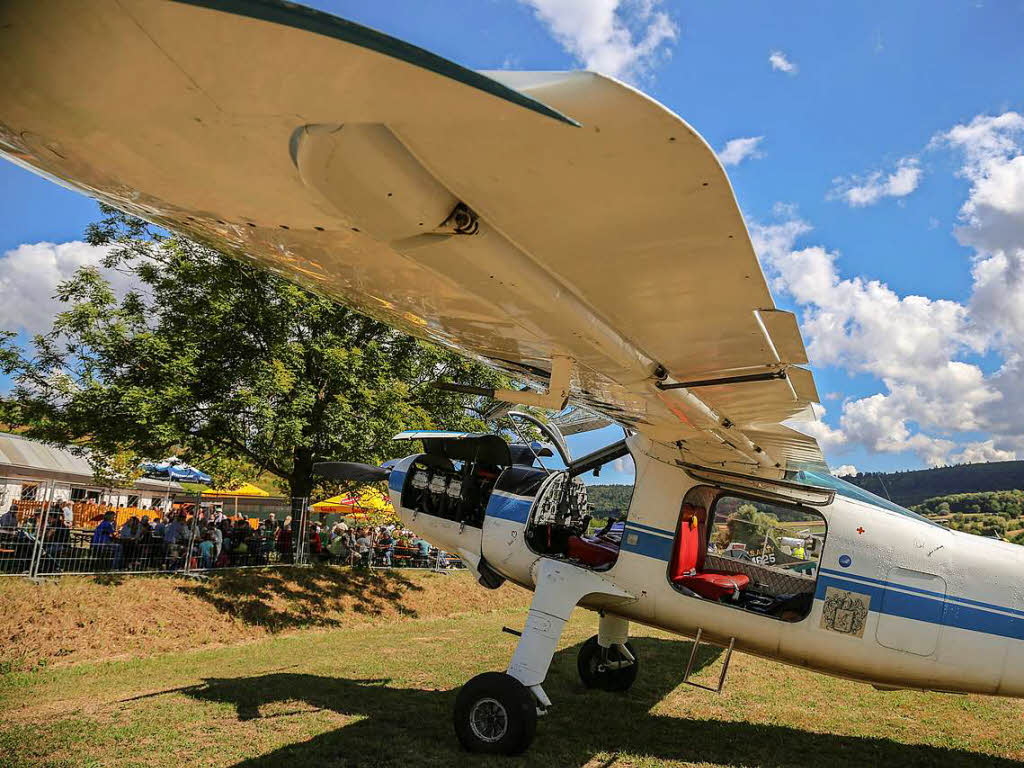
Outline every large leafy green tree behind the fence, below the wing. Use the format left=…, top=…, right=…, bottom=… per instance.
left=0, top=208, right=510, bottom=496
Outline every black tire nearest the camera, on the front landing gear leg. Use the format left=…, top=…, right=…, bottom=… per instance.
left=455, top=672, right=537, bottom=755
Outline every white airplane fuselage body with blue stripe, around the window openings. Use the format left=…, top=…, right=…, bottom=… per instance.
left=390, top=436, right=1024, bottom=697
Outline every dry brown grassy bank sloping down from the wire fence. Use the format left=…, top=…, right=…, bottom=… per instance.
left=0, top=567, right=530, bottom=671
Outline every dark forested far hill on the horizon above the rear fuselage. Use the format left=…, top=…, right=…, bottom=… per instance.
left=843, top=461, right=1024, bottom=507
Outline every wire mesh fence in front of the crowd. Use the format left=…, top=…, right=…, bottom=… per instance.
left=0, top=478, right=463, bottom=579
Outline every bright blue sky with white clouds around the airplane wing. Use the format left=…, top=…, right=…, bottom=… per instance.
left=0, top=0, right=1024, bottom=480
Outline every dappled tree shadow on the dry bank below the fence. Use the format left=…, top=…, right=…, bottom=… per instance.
left=178, top=566, right=423, bottom=632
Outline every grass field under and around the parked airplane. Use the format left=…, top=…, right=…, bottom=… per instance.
left=0, top=571, right=1024, bottom=768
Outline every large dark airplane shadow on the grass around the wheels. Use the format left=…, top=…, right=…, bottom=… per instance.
left=167, top=638, right=1020, bottom=768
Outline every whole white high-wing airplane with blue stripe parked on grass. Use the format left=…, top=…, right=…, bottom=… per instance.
left=0, top=0, right=1024, bottom=754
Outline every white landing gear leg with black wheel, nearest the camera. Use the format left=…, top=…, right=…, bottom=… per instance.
left=455, top=558, right=636, bottom=755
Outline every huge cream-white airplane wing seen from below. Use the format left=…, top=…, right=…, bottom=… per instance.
left=0, top=0, right=823, bottom=477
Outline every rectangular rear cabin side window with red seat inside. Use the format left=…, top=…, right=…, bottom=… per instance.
left=669, top=486, right=826, bottom=622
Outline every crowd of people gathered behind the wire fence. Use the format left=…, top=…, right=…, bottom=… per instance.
left=0, top=502, right=458, bottom=572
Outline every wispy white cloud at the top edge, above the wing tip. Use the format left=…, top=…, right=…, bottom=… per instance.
left=520, top=0, right=679, bottom=80
